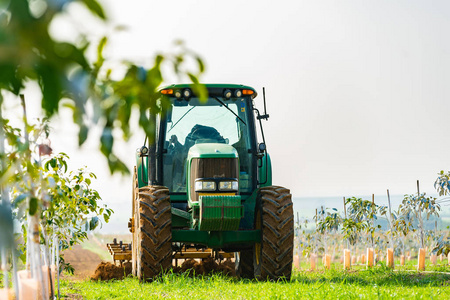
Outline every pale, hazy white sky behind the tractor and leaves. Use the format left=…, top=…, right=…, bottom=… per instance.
left=7, top=0, right=450, bottom=232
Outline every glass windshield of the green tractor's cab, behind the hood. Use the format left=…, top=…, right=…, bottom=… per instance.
left=164, top=98, right=251, bottom=192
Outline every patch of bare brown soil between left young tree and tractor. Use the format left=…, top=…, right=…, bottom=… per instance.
left=64, top=245, right=102, bottom=280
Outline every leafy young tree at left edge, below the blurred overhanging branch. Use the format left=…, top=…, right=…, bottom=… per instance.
left=1, top=119, right=113, bottom=259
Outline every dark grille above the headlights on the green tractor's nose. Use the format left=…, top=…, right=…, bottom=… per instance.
left=190, top=158, right=239, bottom=201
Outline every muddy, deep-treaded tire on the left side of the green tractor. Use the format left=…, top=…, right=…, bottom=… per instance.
left=135, top=186, right=172, bottom=281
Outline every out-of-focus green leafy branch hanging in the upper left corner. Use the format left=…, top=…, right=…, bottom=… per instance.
left=0, top=0, right=206, bottom=173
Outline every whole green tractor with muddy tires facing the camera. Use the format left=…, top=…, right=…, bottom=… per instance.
left=129, top=84, right=294, bottom=280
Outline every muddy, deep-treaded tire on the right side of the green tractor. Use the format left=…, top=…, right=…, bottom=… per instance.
left=255, top=186, right=294, bottom=280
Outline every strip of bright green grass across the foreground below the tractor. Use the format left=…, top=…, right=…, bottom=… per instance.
left=62, top=267, right=450, bottom=300
